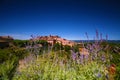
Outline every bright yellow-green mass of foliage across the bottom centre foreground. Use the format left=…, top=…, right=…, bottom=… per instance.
left=13, top=52, right=106, bottom=80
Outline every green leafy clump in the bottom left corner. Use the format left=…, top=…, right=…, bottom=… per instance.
left=0, top=58, right=18, bottom=80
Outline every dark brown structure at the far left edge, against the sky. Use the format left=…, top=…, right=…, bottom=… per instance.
left=0, top=36, right=14, bottom=48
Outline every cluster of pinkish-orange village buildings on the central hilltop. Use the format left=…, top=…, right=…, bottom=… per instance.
left=33, top=35, right=75, bottom=46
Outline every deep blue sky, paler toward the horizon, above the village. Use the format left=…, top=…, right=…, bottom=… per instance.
left=0, top=0, right=120, bottom=40
